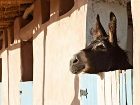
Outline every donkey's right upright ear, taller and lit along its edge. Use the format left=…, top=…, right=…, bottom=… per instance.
left=108, top=12, right=117, bottom=45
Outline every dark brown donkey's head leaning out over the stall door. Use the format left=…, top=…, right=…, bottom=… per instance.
left=70, top=12, right=132, bottom=74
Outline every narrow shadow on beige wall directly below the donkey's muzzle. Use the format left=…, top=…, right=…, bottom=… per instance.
left=71, top=75, right=80, bottom=105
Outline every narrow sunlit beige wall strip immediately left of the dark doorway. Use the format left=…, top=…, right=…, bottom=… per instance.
left=8, top=45, right=21, bottom=105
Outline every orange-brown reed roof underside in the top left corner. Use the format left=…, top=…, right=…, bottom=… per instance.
left=0, top=3, right=31, bottom=28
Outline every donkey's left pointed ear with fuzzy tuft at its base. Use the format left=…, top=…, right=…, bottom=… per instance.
left=91, top=15, right=107, bottom=39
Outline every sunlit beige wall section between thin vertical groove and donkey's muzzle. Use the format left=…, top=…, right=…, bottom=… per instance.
left=44, top=0, right=87, bottom=105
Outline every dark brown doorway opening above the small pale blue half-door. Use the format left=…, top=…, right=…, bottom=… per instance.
left=21, top=40, right=33, bottom=81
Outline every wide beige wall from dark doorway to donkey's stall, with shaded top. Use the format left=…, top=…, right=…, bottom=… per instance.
left=33, top=0, right=87, bottom=105
